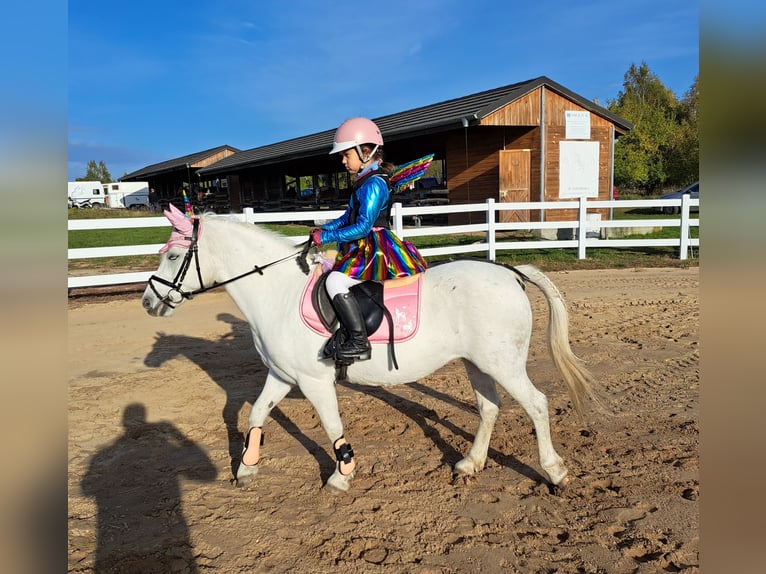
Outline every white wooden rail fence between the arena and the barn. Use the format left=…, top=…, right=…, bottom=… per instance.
left=67, top=196, right=699, bottom=289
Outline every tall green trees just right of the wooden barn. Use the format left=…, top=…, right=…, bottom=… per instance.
left=608, top=62, right=699, bottom=193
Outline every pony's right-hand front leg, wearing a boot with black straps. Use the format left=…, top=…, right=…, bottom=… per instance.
left=298, top=380, right=356, bottom=494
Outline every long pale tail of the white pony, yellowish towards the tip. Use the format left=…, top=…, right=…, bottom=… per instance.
left=514, top=265, right=606, bottom=420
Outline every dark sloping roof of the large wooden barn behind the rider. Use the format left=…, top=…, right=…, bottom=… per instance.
left=200, top=76, right=633, bottom=175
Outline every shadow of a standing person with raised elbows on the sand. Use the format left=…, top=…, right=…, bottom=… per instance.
left=80, top=403, right=217, bottom=574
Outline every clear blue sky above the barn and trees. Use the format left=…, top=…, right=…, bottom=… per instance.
left=67, top=0, right=699, bottom=180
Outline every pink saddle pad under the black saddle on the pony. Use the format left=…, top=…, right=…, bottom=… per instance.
left=300, top=265, right=422, bottom=343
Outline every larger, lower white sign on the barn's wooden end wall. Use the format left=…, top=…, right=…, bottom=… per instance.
left=559, top=141, right=599, bottom=199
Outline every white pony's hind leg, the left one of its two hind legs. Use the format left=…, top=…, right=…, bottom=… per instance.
left=454, top=361, right=500, bottom=475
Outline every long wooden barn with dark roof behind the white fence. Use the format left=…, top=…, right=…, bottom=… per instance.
left=123, top=76, right=633, bottom=224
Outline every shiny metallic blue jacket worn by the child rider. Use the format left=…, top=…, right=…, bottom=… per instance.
left=321, top=168, right=391, bottom=244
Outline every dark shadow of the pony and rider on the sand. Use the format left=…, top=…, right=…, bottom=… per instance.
left=144, top=313, right=544, bottom=482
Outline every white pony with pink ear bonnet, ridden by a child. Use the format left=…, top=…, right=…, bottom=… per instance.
left=142, top=209, right=598, bottom=493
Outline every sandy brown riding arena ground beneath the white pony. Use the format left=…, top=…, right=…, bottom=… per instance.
left=68, top=267, right=699, bottom=574
